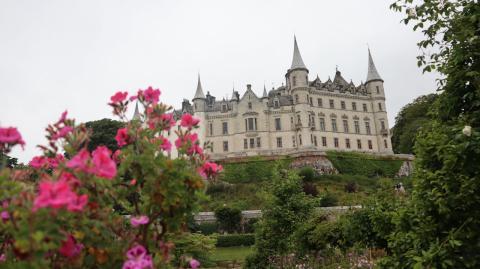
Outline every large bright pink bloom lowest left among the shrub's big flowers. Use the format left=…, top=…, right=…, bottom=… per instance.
left=33, top=180, right=77, bottom=211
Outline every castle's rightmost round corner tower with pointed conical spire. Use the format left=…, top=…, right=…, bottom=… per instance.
left=365, top=49, right=393, bottom=153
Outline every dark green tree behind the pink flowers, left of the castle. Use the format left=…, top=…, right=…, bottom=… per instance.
left=85, top=119, right=124, bottom=152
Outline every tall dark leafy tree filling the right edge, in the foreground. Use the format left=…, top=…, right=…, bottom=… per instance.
left=381, top=0, right=480, bottom=268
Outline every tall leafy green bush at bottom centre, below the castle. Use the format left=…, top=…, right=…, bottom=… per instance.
left=246, top=170, right=313, bottom=268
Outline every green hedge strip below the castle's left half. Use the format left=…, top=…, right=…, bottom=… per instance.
left=220, top=156, right=291, bottom=183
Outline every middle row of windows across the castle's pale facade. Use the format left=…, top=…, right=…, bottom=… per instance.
left=209, top=115, right=386, bottom=136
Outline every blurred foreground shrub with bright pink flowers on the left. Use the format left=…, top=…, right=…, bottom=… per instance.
left=0, top=87, right=222, bottom=269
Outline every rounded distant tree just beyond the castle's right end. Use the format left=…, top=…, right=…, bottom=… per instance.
left=392, top=94, right=437, bottom=154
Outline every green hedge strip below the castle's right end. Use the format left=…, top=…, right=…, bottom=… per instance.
left=327, top=151, right=403, bottom=177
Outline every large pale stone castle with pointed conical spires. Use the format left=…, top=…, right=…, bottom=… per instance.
left=174, top=38, right=393, bottom=159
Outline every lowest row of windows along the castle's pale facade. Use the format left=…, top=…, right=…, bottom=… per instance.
left=216, top=135, right=388, bottom=152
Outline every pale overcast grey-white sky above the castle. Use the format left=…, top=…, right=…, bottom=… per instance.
left=0, top=0, right=436, bottom=162
